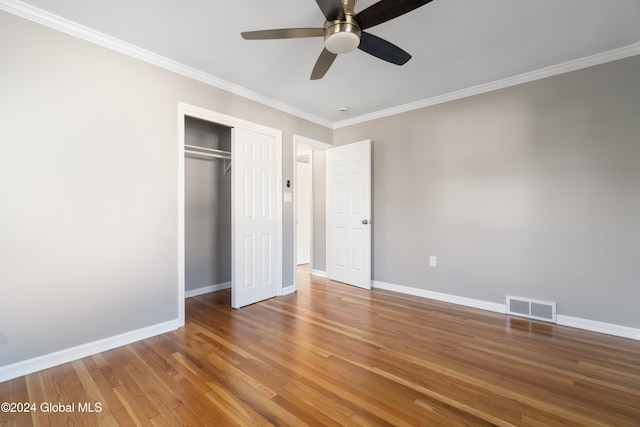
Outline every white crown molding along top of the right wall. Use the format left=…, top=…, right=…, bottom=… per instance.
left=333, top=42, right=640, bottom=129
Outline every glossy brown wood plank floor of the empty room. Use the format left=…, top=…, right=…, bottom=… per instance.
left=0, top=268, right=640, bottom=426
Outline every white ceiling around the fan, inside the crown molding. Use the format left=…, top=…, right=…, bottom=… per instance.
left=6, top=0, right=640, bottom=124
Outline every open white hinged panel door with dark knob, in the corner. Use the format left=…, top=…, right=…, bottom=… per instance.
left=326, top=140, right=371, bottom=289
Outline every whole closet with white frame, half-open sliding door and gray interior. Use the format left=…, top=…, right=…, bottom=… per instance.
left=176, top=102, right=283, bottom=318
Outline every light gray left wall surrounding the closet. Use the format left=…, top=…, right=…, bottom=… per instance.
left=0, top=12, right=332, bottom=367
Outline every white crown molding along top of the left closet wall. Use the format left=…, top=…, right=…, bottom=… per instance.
left=0, top=0, right=333, bottom=128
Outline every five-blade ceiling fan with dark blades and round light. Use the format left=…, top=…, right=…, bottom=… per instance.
left=241, top=0, right=432, bottom=80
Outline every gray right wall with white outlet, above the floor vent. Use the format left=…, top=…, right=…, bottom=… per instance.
left=334, top=56, right=640, bottom=328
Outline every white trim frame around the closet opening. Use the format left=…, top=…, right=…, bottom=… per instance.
left=177, top=102, right=282, bottom=326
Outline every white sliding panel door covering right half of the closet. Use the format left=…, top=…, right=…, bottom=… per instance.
left=231, top=128, right=282, bottom=308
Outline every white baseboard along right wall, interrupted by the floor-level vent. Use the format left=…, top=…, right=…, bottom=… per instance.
left=373, top=280, right=640, bottom=340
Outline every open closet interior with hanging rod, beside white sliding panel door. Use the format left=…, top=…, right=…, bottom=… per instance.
left=184, top=116, right=232, bottom=297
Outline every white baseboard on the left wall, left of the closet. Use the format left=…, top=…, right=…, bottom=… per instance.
left=0, top=319, right=184, bottom=383
